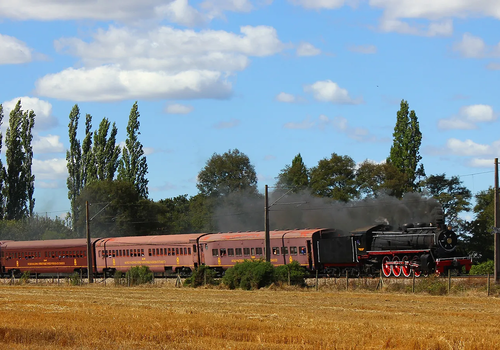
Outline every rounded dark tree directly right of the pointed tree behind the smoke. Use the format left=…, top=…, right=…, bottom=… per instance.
left=311, top=153, right=358, bottom=202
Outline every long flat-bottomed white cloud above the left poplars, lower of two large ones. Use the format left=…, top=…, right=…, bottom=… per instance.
left=35, top=66, right=231, bottom=101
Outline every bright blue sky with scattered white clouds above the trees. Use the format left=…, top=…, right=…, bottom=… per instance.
left=0, top=0, right=500, bottom=216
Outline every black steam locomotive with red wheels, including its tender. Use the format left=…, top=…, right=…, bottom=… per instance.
left=322, top=222, right=472, bottom=277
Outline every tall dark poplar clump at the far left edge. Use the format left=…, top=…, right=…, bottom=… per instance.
left=5, top=100, right=35, bottom=220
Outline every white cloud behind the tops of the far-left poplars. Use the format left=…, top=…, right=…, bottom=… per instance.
left=2, top=96, right=57, bottom=131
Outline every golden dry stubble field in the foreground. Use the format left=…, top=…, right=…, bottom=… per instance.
left=0, top=284, right=500, bottom=350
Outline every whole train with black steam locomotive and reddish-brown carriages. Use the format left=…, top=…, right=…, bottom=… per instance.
left=0, top=224, right=472, bottom=277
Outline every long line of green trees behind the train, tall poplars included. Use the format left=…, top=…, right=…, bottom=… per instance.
left=0, top=100, right=493, bottom=260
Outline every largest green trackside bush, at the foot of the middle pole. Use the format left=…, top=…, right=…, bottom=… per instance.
left=222, top=260, right=274, bottom=290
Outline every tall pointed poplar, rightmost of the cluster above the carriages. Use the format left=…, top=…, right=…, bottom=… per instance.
left=118, top=101, right=148, bottom=198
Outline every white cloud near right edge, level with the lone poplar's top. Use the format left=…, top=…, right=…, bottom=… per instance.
left=438, top=104, right=497, bottom=130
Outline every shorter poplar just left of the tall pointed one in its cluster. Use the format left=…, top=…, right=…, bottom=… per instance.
left=93, top=118, right=120, bottom=180
